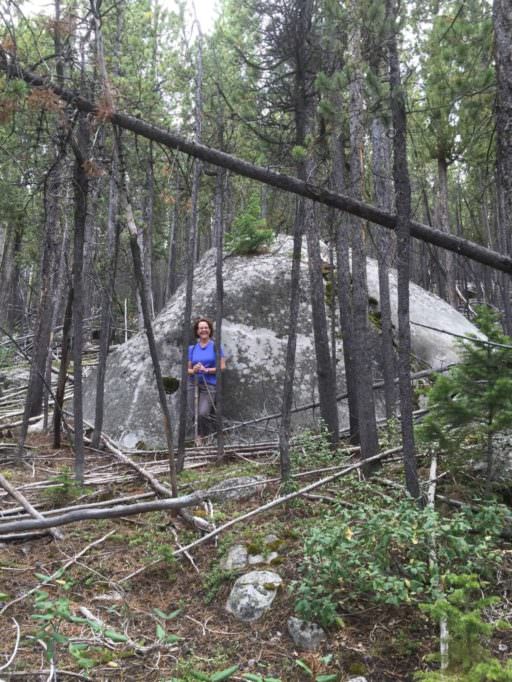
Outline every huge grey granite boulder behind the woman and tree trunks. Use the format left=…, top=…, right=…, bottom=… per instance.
left=84, top=235, right=477, bottom=448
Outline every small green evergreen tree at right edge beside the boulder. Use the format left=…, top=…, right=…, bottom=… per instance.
left=418, top=306, right=512, bottom=486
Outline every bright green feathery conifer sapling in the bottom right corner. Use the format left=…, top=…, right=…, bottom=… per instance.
left=415, top=574, right=512, bottom=682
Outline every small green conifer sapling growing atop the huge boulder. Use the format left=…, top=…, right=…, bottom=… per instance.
left=225, top=193, right=274, bottom=256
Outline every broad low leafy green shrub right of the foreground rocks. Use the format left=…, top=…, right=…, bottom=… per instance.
left=293, top=499, right=505, bottom=626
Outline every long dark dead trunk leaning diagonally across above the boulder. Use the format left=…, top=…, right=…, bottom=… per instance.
left=0, top=47, right=512, bottom=274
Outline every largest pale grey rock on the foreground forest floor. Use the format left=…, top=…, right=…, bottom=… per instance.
left=226, top=571, right=283, bottom=623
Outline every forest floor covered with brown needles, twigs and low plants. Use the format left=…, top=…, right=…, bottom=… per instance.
left=0, top=434, right=512, bottom=682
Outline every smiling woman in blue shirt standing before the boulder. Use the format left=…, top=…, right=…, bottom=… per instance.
left=188, top=317, right=226, bottom=445
